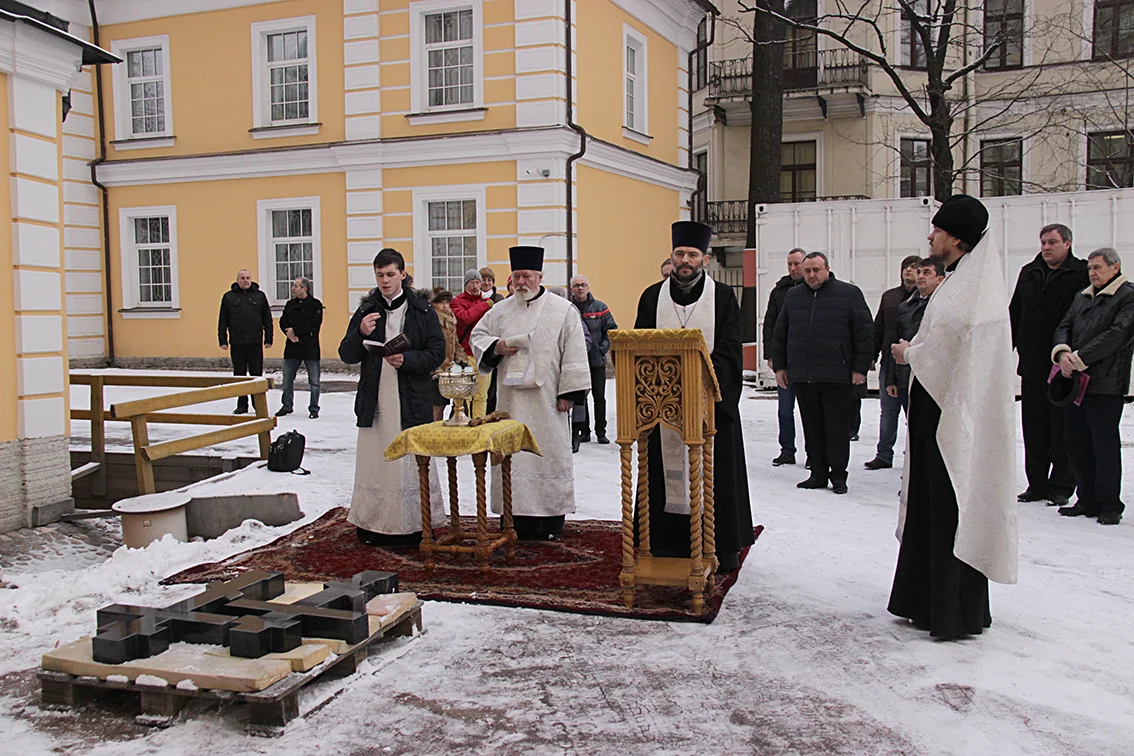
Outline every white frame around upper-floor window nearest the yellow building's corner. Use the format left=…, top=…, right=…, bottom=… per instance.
left=409, top=0, right=484, bottom=124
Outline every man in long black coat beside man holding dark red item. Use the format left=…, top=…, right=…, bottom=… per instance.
left=1008, top=223, right=1088, bottom=506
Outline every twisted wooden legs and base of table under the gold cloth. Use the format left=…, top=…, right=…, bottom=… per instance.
left=417, top=451, right=517, bottom=574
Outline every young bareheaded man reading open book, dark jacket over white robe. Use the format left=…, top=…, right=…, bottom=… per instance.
left=339, top=249, right=446, bottom=546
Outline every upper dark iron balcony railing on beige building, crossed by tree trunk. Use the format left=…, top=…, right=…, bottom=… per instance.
left=709, top=48, right=868, bottom=97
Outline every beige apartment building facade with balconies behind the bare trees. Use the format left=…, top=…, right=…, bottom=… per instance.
left=692, top=0, right=1134, bottom=249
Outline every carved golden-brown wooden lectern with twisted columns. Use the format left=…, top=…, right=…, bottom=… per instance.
left=610, top=329, right=720, bottom=613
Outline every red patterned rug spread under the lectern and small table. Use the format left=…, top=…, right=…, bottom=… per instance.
left=162, top=508, right=763, bottom=622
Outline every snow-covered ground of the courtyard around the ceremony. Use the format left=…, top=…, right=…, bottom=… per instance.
left=0, top=376, right=1134, bottom=756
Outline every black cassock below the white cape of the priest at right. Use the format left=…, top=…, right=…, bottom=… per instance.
left=889, top=379, right=992, bottom=638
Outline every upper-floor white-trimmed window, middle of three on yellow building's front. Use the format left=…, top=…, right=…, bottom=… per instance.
left=252, top=16, right=319, bottom=129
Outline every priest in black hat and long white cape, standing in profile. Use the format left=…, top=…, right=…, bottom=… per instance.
left=889, top=195, right=1018, bottom=639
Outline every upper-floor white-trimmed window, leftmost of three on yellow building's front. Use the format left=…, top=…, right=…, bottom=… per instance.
left=111, top=35, right=174, bottom=141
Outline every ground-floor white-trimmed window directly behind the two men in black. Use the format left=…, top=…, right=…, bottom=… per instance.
left=256, top=197, right=322, bottom=306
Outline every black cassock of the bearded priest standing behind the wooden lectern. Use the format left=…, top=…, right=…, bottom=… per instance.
left=634, top=278, right=755, bottom=571
